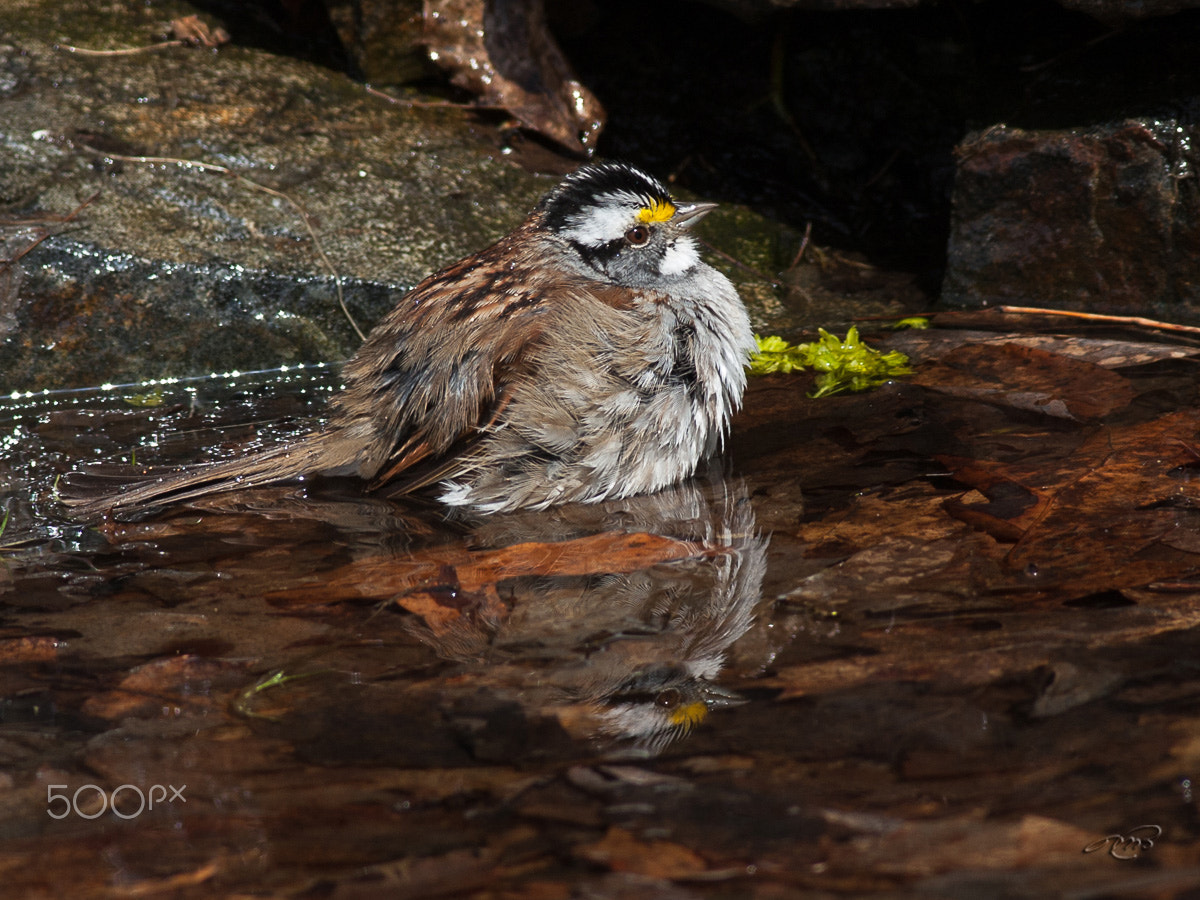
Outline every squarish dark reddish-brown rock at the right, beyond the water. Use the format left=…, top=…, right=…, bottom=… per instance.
left=943, top=119, right=1200, bottom=319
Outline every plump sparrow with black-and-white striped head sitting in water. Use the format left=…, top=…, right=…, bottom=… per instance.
left=65, top=163, right=754, bottom=514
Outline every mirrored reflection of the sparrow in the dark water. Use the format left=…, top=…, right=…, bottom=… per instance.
left=419, top=472, right=767, bottom=754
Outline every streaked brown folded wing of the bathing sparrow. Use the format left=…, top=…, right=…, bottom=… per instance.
left=331, top=232, right=587, bottom=486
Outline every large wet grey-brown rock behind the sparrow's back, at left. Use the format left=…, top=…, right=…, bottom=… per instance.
left=0, top=0, right=787, bottom=392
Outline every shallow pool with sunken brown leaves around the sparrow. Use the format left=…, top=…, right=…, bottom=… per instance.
left=7, top=329, right=1200, bottom=898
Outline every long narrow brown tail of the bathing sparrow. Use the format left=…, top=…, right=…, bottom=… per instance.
left=59, top=432, right=352, bottom=518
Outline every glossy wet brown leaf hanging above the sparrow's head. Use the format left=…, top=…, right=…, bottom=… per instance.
left=425, top=0, right=605, bottom=155
